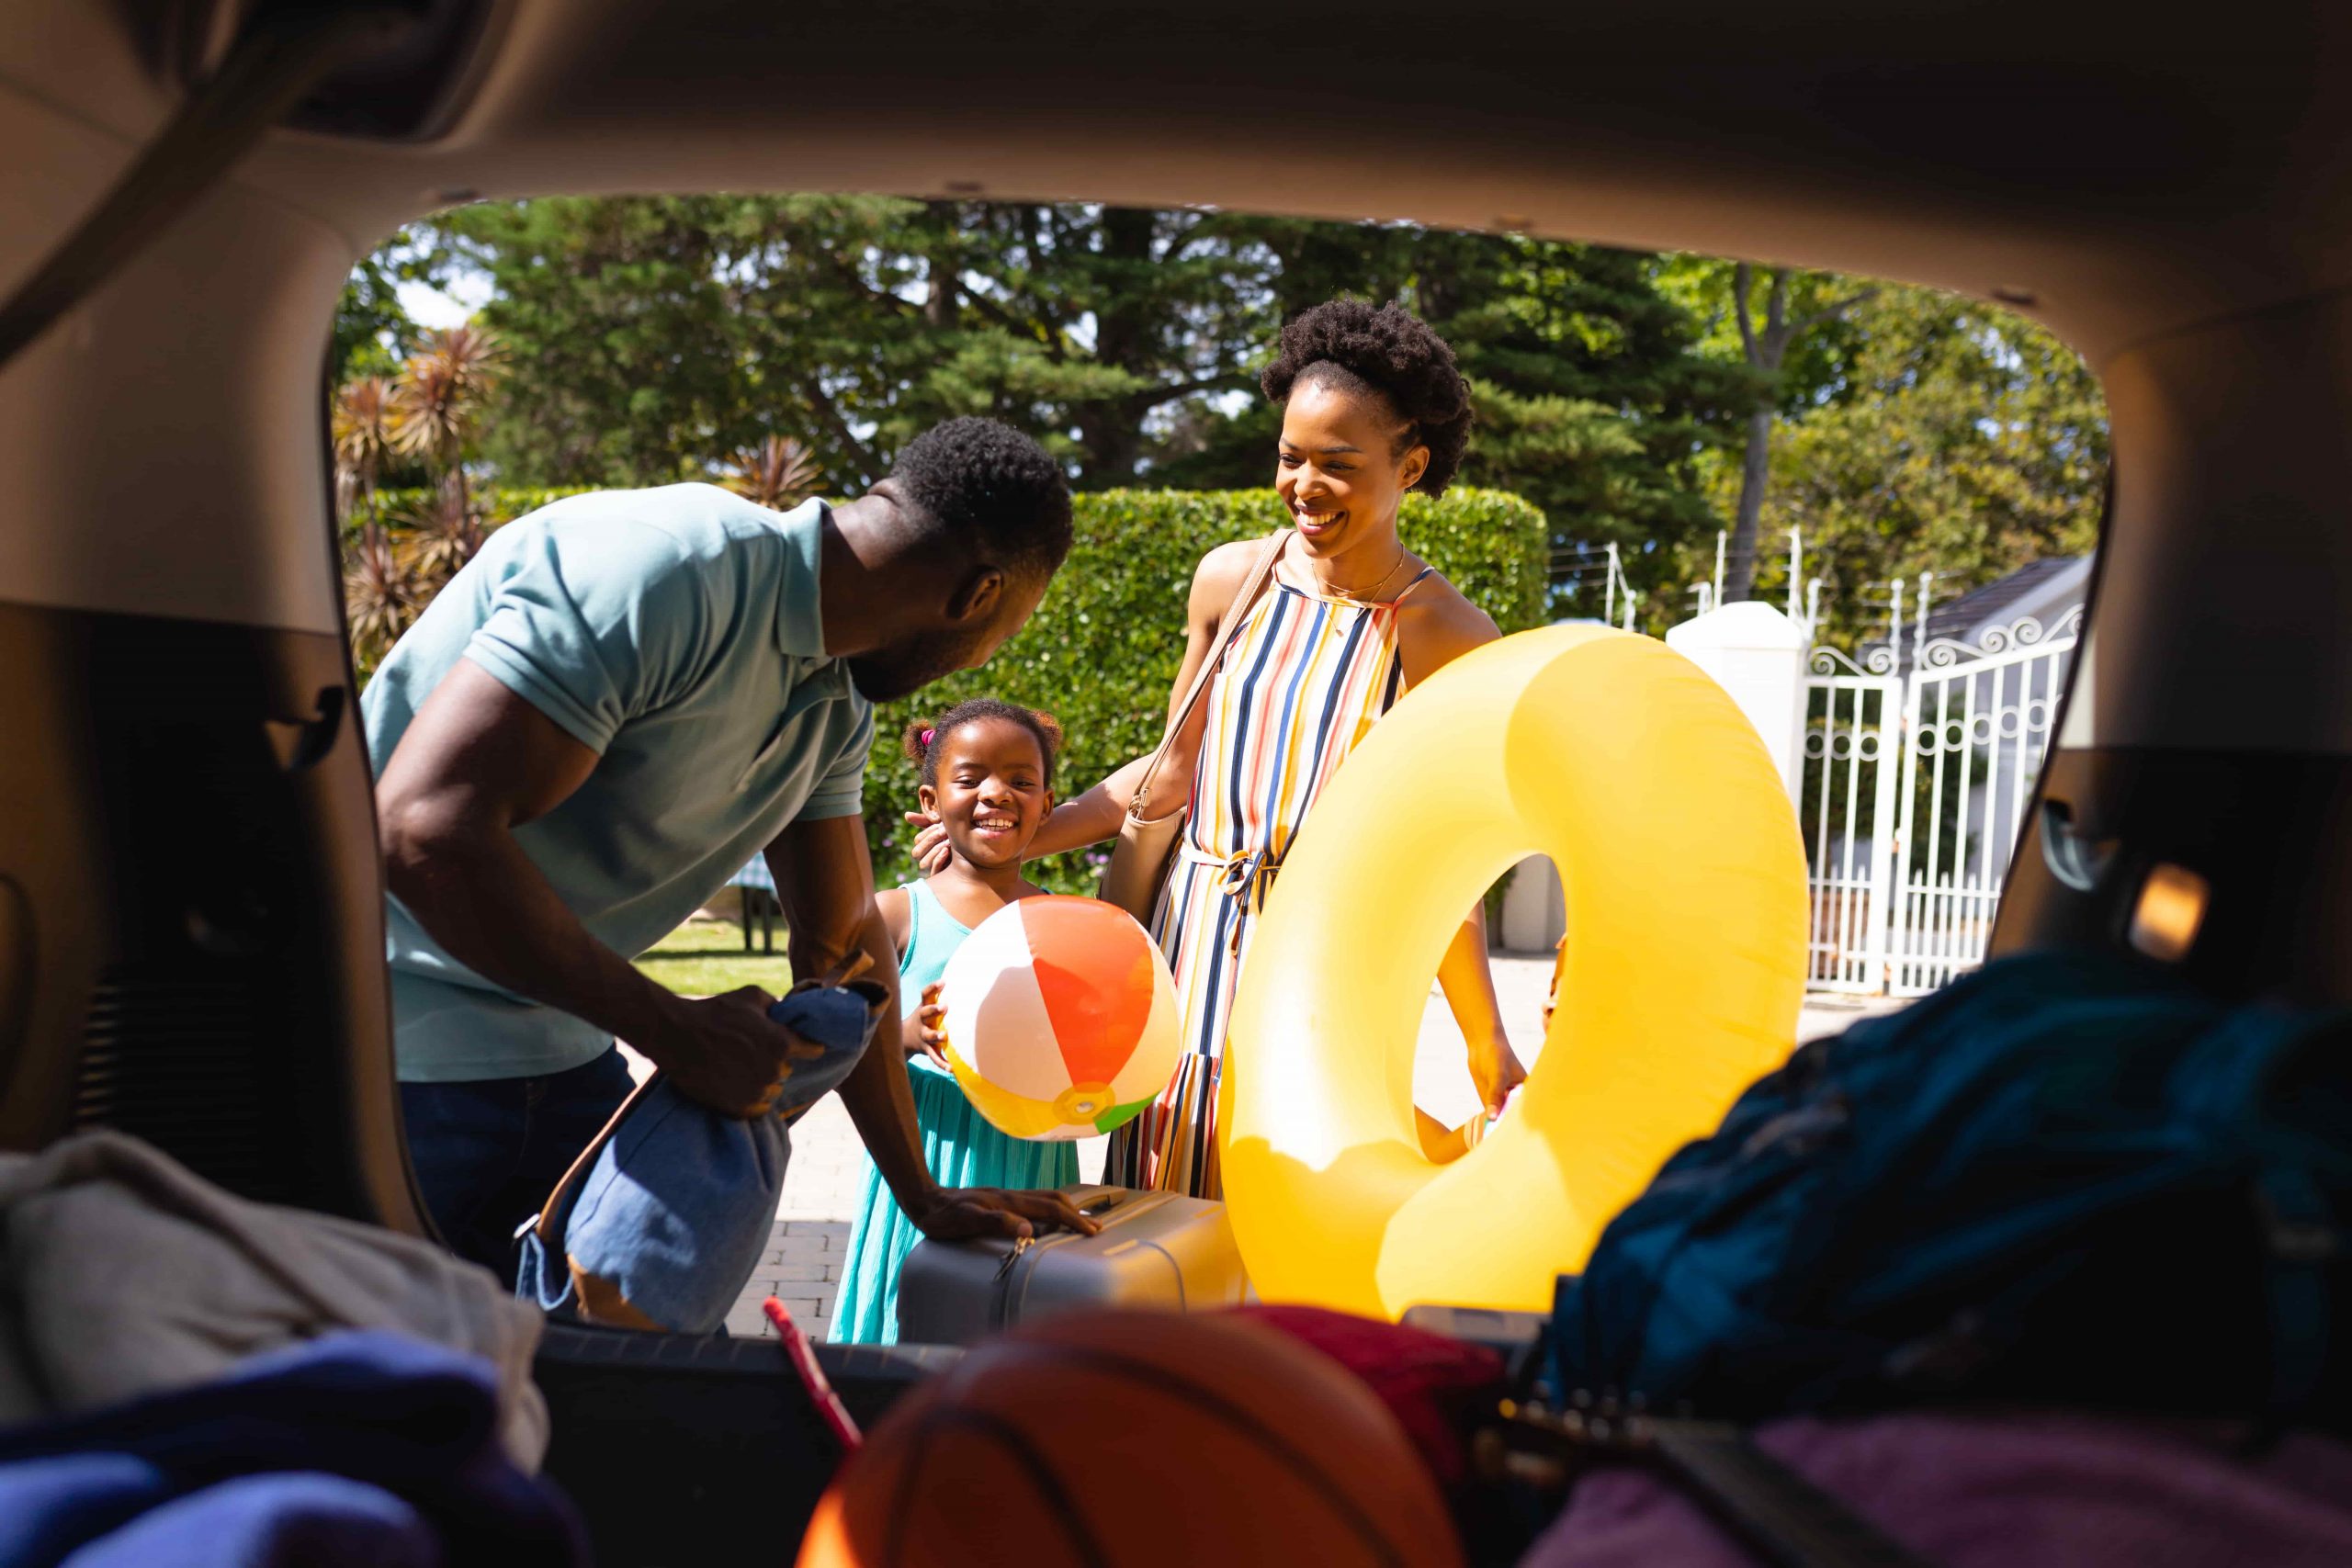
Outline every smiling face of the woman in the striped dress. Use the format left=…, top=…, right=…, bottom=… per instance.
left=1275, top=378, right=1430, bottom=558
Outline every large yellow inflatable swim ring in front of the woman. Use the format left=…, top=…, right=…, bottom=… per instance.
left=1218, top=627, right=1806, bottom=1319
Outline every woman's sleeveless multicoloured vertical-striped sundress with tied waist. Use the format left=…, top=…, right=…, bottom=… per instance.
left=1103, top=545, right=1432, bottom=1199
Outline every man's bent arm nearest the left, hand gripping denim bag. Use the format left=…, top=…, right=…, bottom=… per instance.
left=377, top=659, right=793, bottom=1117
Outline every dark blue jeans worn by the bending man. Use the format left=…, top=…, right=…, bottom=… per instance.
left=400, top=1051, right=630, bottom=1281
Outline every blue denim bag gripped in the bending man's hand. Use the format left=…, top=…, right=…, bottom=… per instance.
left=515, top=980, right=889, bottom=1333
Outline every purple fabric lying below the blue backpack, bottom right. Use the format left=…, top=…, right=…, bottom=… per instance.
left=1520, top=1413, right=2352, bottom=1568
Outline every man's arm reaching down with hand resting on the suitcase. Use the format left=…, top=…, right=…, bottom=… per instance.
left=767, top=816, right=1099, bottom=1239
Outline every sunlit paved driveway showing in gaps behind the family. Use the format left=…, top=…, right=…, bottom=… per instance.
left=630, top=952, right=1900, bottom=1340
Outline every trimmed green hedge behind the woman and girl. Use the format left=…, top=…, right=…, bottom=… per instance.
left=865, top=489, right=1547, bottom=891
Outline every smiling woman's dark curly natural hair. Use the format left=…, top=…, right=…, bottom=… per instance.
left=1259, top=299, right=1470, bottom=496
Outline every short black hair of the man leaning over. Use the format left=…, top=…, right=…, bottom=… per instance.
left=889, top=419, right=1070, bottom=581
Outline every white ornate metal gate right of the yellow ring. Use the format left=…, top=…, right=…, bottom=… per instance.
left=1797, top=604, right=2082, bottom=997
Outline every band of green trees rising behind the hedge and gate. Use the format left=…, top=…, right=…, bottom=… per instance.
left=336, top=195, right=2105, bottom=658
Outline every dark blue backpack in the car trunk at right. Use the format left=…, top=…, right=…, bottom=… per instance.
left=1553, top=954, right=2352, bottom=1432
